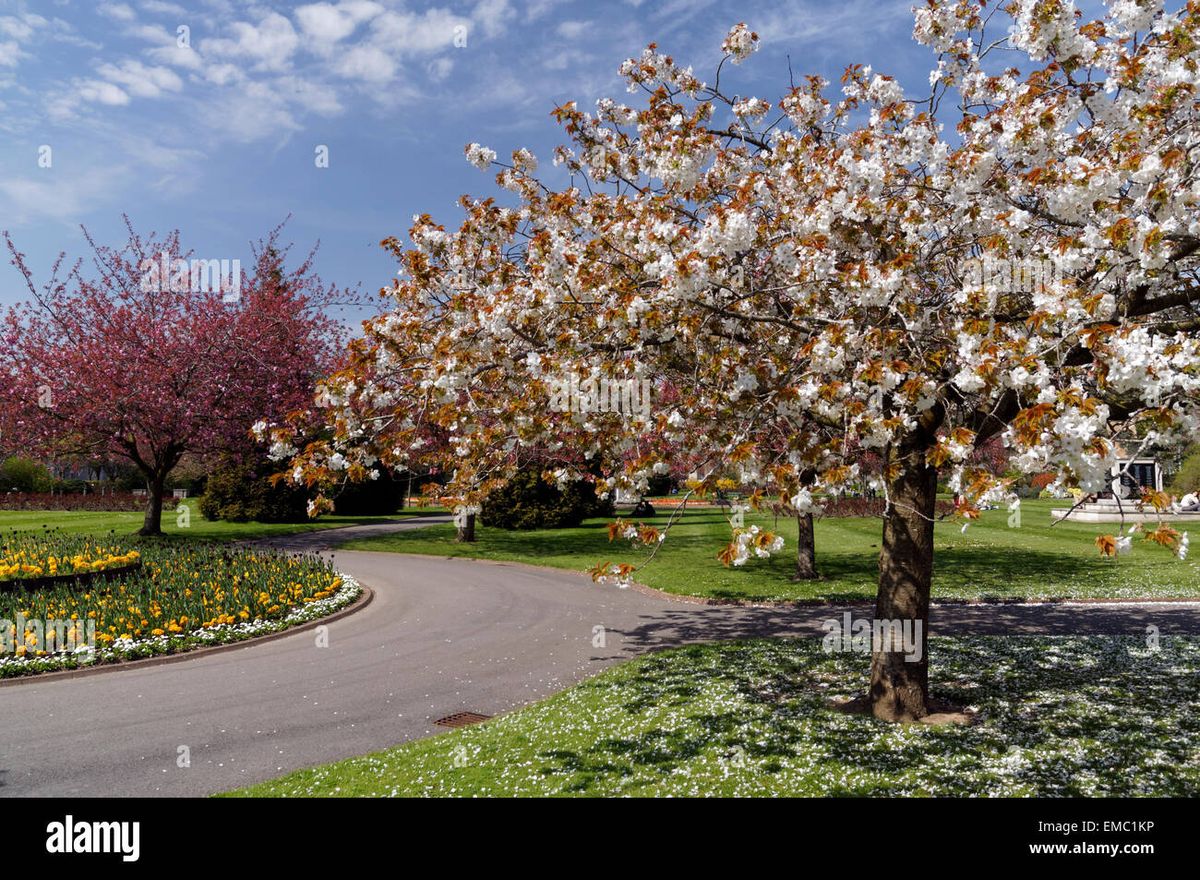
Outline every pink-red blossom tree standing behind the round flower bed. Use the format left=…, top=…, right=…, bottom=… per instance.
left=0, top=217, right=350, bottom=534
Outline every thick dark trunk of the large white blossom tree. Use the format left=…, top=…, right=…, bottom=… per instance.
left=868, top=439, right=937, bottom=722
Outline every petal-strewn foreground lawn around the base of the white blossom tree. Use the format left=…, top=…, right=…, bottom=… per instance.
left=233, top=636, right=1200, bottom=797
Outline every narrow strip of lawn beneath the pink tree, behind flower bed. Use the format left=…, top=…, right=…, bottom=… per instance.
left=0, top=498, right=436, bottom=540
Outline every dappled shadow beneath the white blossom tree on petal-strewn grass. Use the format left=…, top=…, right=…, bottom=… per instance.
left=540, top=637, right=1200, bottom=796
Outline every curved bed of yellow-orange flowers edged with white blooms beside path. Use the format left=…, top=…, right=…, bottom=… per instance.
left=0, top=543, right=362, bottom=678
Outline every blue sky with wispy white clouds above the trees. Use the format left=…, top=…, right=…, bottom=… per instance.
left=0, top=0, right=932, bottom=316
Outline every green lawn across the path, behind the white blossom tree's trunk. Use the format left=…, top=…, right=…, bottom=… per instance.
left=342, top=501, right=1200, bottom=601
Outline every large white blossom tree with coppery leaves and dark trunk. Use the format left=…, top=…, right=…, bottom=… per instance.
left=274, top=0, right=1200, bottom=720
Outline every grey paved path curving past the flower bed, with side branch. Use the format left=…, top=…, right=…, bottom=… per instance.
left=0, top=517, right=1200, bottom=796
